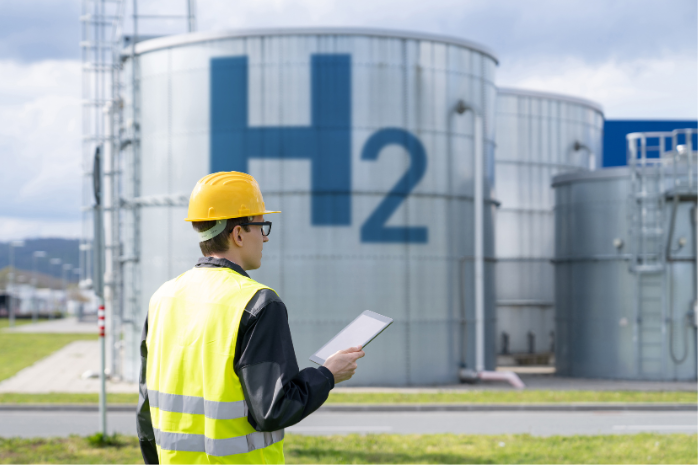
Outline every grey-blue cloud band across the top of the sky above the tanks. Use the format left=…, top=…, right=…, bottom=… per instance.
left=0, top=0, right=698, bottom=63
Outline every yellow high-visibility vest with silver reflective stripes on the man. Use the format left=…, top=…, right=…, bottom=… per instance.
left=146, top=268, right=284, bottom=463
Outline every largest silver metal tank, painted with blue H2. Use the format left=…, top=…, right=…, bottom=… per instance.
left=124, top=29, right=497, bottom=385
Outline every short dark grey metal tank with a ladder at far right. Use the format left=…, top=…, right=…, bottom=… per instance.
left=553, top=130, right=698, bottom=380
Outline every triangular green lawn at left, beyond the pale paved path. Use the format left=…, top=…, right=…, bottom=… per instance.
left=0, top=332, right=97, bottom=381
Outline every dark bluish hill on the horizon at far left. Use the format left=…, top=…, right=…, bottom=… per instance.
left=0, top=238, right=80, bottom=281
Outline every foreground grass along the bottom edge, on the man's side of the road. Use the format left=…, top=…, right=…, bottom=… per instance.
left=0, top=433, right=698, bottom=463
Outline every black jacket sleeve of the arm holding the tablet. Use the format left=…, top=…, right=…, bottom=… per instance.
left=234, top=289, right=334, bottom=431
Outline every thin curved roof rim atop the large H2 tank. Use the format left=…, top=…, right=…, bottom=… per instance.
left=136, top=27, right=499, bottom=64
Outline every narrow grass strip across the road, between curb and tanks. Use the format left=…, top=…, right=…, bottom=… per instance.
left=0, top=391, right=697, bottom=405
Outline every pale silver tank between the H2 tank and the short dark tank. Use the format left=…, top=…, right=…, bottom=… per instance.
left=495, top=88, right=603, bottom=364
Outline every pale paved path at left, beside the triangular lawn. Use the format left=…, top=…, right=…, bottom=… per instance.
left=0, top=341, right=138, bottom=394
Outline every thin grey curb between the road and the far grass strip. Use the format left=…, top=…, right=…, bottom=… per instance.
left=0, top=403, right=698, bottom=414
